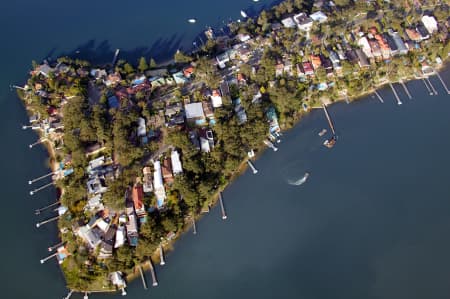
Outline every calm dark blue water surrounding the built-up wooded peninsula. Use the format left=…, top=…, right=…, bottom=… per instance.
left=0, top=0, right=450, bottom=299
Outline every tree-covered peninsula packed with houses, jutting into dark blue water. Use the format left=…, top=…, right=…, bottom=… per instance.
left=17, top=0, right=450, bottom=292
